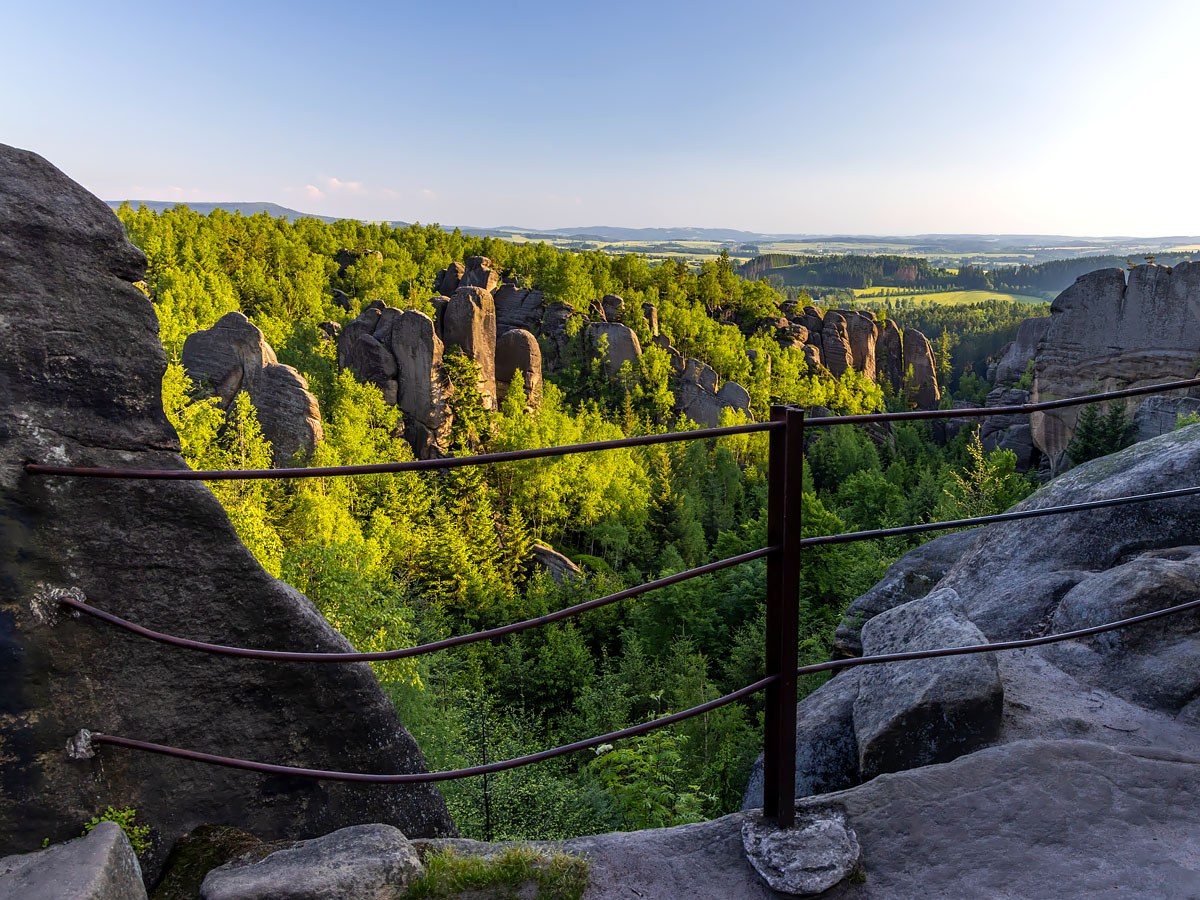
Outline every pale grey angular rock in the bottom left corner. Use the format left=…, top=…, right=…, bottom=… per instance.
left=0, top=822, right=146, bottom=900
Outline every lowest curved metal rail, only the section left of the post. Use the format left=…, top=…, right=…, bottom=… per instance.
left=90, top=676, right=779, bottom=785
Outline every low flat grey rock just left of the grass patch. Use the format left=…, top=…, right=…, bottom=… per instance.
left=200, top=824, right=425, bottom=900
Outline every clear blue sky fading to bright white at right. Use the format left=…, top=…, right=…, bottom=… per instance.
left=0, top=0, right=1200, bottom=236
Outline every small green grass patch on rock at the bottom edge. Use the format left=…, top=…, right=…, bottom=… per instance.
left=404, top=845, right=588, bottom=900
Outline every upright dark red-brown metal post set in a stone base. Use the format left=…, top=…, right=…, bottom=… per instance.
left=762, top=407, right=804, bottom=828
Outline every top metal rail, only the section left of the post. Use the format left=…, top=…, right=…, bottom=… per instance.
left=25, top=421, right=779, bottom=481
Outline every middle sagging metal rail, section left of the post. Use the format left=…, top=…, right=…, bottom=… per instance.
left=59, top=547, right=779, bottom=662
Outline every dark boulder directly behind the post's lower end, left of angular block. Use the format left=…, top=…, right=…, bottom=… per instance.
left=742, top=668, right=863, bottom=809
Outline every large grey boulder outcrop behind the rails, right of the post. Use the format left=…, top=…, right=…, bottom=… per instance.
left=746, top=426, right=1200, bottom=816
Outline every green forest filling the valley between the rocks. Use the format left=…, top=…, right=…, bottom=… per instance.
left=119, top=205, right=1033, bottom=840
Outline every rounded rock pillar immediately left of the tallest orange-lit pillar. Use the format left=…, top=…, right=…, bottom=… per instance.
left=390, top=310, right=454, bottom=460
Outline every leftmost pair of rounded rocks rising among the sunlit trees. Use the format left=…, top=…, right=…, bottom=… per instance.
left=182, top=312, right=325, bottom=467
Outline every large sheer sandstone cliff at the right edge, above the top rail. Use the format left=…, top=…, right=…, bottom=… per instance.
left=1031, top=263, right=1200, bottom=467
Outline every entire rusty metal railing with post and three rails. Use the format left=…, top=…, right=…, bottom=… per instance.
left=25, top=378, right=1200, bottom=827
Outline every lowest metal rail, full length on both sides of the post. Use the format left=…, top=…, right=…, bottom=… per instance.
left=71, top=600, right=1200, bottom=784
